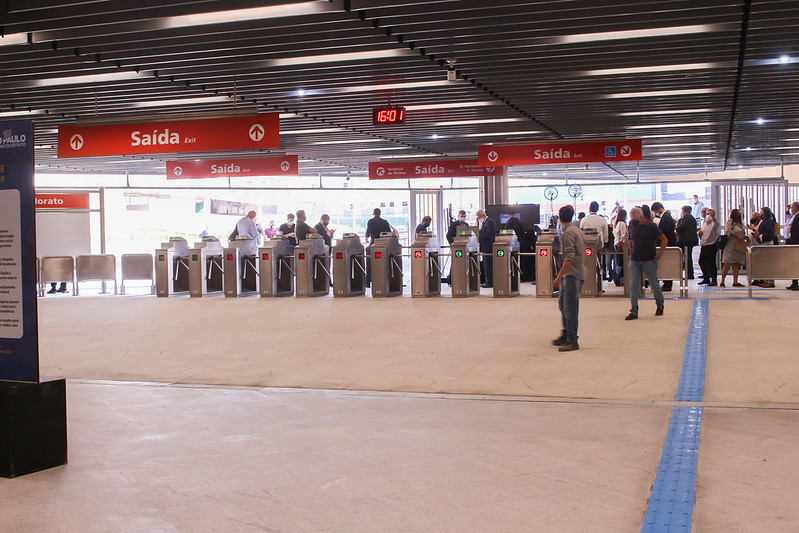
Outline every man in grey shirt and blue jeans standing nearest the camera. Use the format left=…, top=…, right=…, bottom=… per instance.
left=552, top=205, right=585, bottom=352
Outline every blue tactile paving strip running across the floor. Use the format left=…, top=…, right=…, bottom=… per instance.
left=641, top=299, right=710, bottom=533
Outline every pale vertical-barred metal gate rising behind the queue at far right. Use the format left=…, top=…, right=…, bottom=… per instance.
left=711, top=178, right=793, bottom=224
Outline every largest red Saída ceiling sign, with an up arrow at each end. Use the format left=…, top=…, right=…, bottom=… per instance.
left=58, top=113, right=280, bottom=157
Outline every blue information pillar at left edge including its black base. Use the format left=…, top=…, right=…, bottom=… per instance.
left=0, top=121, right=67, bottom=477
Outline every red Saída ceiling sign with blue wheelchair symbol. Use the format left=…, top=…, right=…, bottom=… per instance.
left=477, top=139, right=643, bottom=166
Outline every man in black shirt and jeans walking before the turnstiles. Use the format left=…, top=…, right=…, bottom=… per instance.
left=625, top=207, right=669, bottom=320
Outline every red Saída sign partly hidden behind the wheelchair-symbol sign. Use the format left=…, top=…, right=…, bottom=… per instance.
left=369, top=159, right=502, bottom=180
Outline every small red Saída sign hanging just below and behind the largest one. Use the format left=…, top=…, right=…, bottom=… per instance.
left=166, top=155, right=299, bottom=180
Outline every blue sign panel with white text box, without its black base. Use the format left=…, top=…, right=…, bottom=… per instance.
left=0, top=121, right=39, bottom=382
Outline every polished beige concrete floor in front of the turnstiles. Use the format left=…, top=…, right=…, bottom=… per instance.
left=0, top=282, right=799, bottom=532
